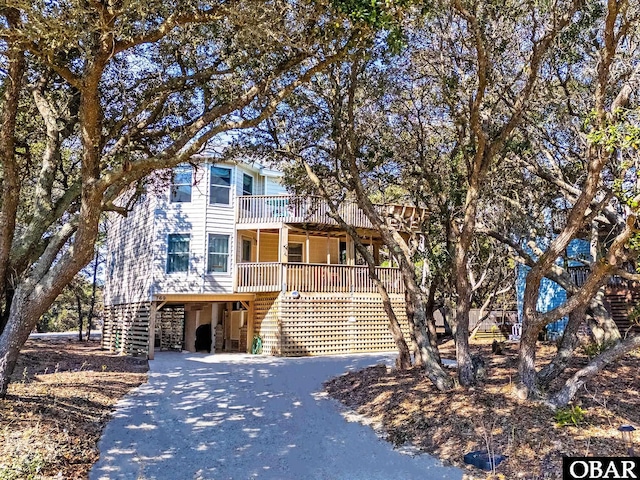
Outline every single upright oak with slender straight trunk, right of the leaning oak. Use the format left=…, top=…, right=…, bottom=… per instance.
left=310, top=0, right=581, bottom=385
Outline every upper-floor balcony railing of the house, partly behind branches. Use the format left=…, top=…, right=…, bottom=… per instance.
left=237, top=195, right=425, bottom=232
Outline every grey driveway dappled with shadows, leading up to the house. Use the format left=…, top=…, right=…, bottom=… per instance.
left=89, top=352, right=463, bottom=480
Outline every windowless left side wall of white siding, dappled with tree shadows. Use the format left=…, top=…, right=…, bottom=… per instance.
left=105, top=191, right=155, bottom=305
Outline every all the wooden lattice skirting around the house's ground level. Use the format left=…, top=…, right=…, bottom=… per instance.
left=102, top=293, right=416, bottom=356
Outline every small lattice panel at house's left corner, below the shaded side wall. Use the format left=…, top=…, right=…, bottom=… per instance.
left=102, top=303, right=150, bottom=355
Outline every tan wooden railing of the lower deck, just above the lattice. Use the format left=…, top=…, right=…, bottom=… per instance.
left=236, top=262, right=404, bottom=293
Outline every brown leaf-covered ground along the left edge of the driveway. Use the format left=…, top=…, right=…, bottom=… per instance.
left=0, top=339, right=148, bottom=480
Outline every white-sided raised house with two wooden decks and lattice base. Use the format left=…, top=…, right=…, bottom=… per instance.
left=102, top=159, right=420, bottom=358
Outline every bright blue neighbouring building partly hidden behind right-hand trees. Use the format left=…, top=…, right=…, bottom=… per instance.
left=516, top=239, right=590, bottom=339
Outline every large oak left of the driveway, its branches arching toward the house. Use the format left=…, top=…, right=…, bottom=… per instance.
left=0, top=0, right=363, bottom=397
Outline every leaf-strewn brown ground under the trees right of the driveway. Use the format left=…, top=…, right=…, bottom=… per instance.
left=325, top=343, right=640, bottom=479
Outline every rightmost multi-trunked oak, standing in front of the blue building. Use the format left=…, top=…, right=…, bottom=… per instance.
left=504, top=1, right=640, bottom=406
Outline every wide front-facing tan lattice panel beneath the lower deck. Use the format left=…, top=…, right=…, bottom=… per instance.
left=279, top=294, right=409, bottom=356
